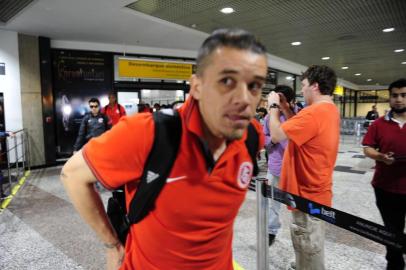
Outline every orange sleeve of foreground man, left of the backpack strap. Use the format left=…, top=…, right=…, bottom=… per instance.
left=83, top=114, right=154, bottom=189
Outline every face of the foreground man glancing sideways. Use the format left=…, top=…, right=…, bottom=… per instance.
left=190, top=47, right=267, bottom=140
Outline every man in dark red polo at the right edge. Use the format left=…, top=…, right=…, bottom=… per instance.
left=362, top=79, right=406, bottom=270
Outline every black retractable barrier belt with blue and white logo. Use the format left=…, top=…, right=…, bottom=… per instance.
left=263, top=182, right=406, bottom=253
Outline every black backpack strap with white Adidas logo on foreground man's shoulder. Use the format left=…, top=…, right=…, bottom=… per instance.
left=128, top=109, right=182, bottom=224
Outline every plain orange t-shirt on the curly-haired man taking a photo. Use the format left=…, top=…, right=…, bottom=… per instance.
left=279, top=102, right=340, bottom=206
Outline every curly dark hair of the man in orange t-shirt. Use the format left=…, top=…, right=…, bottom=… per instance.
left=300, top=65, right=337, bottom=96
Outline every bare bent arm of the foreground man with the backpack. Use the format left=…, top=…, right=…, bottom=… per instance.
left=61, top=151, right=124, bottom=269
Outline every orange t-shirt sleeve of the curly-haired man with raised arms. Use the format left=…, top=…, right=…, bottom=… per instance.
left=281, top=107, right=323, bottom=146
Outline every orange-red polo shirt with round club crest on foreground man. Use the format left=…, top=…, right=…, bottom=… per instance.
left=83, top=98, right=264, bottom=270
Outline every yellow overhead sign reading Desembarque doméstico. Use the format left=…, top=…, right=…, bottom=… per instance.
left=118, top=59, right=193, bottom=80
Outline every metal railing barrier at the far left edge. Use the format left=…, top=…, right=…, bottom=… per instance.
left=0, top=129, right=31, bottom=212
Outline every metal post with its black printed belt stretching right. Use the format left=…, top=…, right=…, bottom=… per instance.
left=255, top=178, right=406, bottom=270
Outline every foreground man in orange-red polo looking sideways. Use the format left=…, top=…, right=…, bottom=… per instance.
left=61, top=29, right=267, bottom=270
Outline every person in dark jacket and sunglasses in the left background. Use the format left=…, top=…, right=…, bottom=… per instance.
left=73, top=98, right=111, bottom=152
